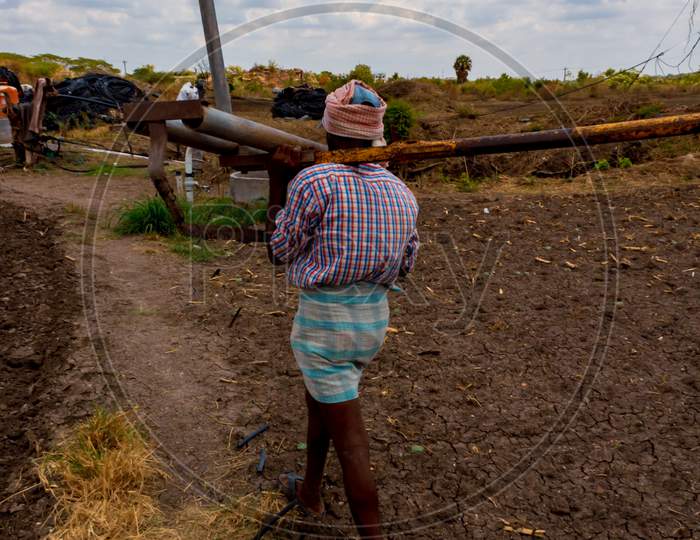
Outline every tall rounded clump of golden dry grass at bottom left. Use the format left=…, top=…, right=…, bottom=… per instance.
left=39, top=410, right=177, bottom=540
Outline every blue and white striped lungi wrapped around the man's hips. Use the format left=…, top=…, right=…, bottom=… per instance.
left=292, top=282, right=389, bottom=403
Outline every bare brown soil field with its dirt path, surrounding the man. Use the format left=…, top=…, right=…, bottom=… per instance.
left=0, top=89, right=700, bottom=539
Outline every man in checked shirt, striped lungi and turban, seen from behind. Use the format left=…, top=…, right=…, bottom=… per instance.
left=268, top=81, right=418, bottom=537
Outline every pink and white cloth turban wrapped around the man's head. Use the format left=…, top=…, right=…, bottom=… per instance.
left=322, top=80, right=386, bottom=141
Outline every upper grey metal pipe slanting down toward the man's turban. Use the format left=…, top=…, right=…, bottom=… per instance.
left=184, top=108, right=327, bottom=152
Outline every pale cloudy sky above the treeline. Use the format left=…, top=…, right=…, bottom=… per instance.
left=0, top=0, right=700, bottom=78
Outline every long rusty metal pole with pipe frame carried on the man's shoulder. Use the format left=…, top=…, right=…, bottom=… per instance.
left=125, top=101, right=700, bottom=242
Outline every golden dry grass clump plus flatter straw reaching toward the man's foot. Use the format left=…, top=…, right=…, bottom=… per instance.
left=38, top=410, right=292, bottom=540
